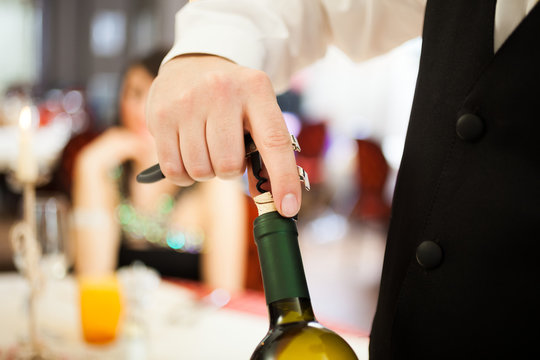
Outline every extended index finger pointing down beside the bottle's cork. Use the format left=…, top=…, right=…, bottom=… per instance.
left=246, top=73, right=301, bottom=217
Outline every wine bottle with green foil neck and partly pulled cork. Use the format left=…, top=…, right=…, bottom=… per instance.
left=251, top=193, right=358, bottom=360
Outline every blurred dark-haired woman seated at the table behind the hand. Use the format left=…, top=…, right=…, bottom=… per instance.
left=72, top=51, right=247, bottom=291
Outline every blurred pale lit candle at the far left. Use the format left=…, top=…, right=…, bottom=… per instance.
left=17, top=106, right=38, bottom=183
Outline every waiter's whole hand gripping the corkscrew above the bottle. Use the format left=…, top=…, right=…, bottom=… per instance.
left=147, top=55, right=301, bottom=217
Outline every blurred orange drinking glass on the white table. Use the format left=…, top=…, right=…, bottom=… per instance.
left=79, top=275, right=122, bottom=344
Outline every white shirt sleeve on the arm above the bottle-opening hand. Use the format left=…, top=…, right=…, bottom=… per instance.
left=164, top=0, right=425, bottom=91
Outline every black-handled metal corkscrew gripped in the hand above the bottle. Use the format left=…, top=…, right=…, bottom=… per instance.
left=137, top=133, right=311, bottom=193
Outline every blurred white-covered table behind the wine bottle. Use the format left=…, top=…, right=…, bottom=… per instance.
left=0, top=273, right=369, bottom=360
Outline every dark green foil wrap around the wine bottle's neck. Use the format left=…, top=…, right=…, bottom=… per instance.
left=253, top=211, right=311, bottom=308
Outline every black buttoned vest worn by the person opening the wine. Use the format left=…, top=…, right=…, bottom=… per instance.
left=370, top=0, right=540, bottom=360
